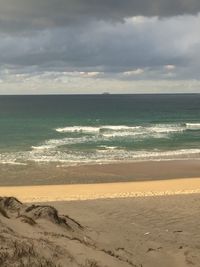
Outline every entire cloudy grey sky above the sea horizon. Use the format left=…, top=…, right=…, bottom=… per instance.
left=0, top=0, right=200, bottom=94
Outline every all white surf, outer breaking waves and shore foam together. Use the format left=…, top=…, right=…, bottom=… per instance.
left=0, top=122, right=200, bottom=165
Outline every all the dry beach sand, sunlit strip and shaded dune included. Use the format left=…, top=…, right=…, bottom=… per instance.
left=0, top=175, right=200, bottom=267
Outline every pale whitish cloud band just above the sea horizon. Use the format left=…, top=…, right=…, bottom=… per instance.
left=0, top=67, right=200, bottom=94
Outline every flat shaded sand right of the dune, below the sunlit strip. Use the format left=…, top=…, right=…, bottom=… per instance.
left=52, top=194, right=200, bottom=267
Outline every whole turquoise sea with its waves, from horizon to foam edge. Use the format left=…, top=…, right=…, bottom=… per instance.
left=0, top=94, right=200, bottom=165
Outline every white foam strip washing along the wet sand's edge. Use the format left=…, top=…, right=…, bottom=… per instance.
left=0, top=146, right=200, bottom=165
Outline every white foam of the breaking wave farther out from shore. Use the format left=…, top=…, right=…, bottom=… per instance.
left=32, top=124, right=188, bottom=153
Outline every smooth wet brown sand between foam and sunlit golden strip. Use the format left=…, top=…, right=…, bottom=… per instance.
left=0, top=159, right=200, bottom=186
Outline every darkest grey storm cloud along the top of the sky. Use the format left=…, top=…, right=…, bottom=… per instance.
left=0, top=0, right=200, bottom=31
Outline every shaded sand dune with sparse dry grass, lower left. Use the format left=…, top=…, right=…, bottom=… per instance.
left=0, top=198, right=134, bottom=267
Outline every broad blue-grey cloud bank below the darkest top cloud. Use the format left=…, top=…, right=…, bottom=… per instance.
left=0, top=15, right=200, bottom=74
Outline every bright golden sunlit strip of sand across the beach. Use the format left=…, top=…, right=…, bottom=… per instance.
left=0, top=178, right=200, bottom=202
